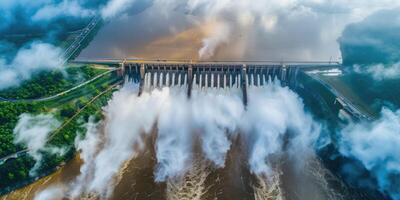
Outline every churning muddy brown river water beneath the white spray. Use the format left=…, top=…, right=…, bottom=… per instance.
left=0, top=131, right=360, bottom=200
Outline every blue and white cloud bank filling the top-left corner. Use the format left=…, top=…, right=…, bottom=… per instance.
left=0, top=0, right=142, bottom=90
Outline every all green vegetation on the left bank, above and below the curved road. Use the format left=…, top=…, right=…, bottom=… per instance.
left=0, top=67, right=120, bottom=194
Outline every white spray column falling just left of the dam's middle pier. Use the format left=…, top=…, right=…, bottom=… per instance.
left=155, top=87, right=192, bottom=181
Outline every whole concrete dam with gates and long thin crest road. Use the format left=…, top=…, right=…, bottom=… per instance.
left=72, top=59, right=341, bottom=108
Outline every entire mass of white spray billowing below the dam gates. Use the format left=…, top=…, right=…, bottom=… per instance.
left=36, top=80, right=322, bottom=198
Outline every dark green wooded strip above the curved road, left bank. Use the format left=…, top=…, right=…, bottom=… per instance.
left=0, top=66, right=105, bottom=99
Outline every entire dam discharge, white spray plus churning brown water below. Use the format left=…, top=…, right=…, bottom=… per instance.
left=1, top=79, right=360, bottom=200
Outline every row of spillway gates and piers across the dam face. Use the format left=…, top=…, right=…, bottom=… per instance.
left=120, top=63, right=298, bottom=104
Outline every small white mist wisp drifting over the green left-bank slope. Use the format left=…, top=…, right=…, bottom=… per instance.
left=14, top=113, right=64, bottom=175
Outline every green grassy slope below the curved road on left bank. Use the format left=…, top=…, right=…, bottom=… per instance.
left=0, top=69, right=119, bottom=193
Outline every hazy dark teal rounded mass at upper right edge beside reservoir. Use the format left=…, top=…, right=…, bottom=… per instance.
left=339, top=6, right=400, bottom=65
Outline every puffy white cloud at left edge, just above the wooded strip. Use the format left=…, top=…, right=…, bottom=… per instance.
left=0, top=42, right=63, bottom=89
